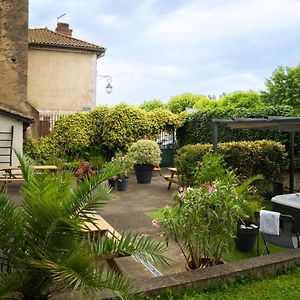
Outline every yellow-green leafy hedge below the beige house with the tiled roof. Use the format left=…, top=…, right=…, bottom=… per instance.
left=25, top=104, right=186, bottom=161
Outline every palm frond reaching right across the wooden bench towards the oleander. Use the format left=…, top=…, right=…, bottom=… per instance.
left=89, top=233, right=169, bottom=266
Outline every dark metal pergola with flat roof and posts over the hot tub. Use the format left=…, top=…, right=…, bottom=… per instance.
left=212, top=116, right=300, bottom=193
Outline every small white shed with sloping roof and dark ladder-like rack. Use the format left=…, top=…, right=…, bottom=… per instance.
left=0, top=105, right=34, bottom=166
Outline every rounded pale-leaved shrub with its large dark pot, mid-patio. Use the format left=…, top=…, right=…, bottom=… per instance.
left=128, top=140, right=161, bottom=183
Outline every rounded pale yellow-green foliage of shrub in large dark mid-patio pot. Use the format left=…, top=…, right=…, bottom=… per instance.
left=128, top=140, right=161, bottom=165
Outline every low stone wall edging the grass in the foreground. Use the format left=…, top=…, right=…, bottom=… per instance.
left=135, top=249, right=300, bottom=296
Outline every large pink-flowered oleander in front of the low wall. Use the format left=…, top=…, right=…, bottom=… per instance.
left=158, top=180, right=251, bottom=269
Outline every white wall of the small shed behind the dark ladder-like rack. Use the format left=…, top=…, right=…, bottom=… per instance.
left=0, top=114, right=23, bottom=166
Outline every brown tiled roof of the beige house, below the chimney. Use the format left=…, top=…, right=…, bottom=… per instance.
left=28, top=28, right=106, bottom=56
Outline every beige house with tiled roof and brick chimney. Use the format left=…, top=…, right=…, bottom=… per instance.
left=28, top=23, right=106, bottom=115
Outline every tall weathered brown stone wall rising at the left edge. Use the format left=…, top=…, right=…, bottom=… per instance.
left=0, top=0, right=38, bottom=136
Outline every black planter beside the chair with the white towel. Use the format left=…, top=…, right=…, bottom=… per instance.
left=235, top=224, right=259, bottom=252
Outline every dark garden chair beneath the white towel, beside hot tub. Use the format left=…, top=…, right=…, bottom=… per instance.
left=255, top=212, right=300, bottom=255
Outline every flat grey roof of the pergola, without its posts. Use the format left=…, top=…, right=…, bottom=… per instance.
left=212, top=116, right=300, bottom=132
